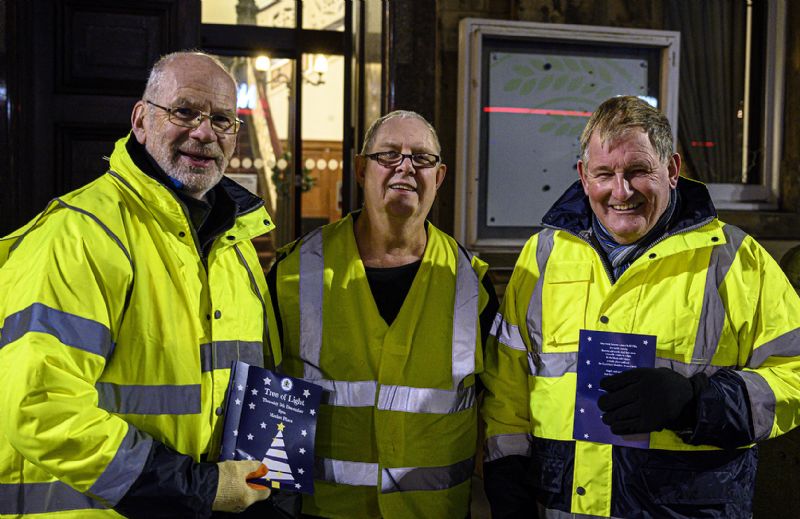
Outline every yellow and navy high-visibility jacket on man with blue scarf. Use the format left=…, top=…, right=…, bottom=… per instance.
left=482, top=178, right=800, bottom=518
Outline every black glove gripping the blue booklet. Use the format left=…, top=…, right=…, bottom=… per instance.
left=597, top=368, right=708, bottom=434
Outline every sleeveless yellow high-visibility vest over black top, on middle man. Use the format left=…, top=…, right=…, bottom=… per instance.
left=273, top=215, right=489, bottom=518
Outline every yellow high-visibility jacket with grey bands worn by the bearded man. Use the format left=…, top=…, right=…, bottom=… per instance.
left=0, top=138, right=280, bottom=519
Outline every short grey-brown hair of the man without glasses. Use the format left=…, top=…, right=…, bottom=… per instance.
left=581, top=96, right=674, bottom=163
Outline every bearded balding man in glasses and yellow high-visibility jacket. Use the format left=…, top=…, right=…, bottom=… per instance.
left=0, top=52, right=288, bottom=519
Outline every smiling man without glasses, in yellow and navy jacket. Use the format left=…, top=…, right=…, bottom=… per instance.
left=482, top=97, right=800, bottom=518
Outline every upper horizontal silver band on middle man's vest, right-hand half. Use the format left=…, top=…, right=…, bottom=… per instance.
left=378, top=386, right=475, bottom=414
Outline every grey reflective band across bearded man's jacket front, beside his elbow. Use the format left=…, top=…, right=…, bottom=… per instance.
left=95, top=382, right=200, bottom=414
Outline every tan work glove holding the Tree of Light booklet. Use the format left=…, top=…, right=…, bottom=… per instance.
left=211, top=461, right=270, bottom=512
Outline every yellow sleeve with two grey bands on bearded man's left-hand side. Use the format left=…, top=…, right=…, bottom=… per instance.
left=0, top=209, right=152, bottom=505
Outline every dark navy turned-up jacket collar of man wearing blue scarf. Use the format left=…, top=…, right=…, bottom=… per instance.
left=542, top=177, right=717, bottom=236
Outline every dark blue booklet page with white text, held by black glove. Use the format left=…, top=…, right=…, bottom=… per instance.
left=572, top=330, right=656, bottom=449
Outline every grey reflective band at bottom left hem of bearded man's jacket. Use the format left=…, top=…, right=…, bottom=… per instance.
left=0, top=481, right=106, bottom=516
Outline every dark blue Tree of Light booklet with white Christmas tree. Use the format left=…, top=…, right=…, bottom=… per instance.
left=220, top=362, right=323, bottom=494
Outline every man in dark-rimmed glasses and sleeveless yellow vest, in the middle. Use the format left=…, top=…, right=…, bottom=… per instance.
left=269, top=111, right=497, bottom=518
